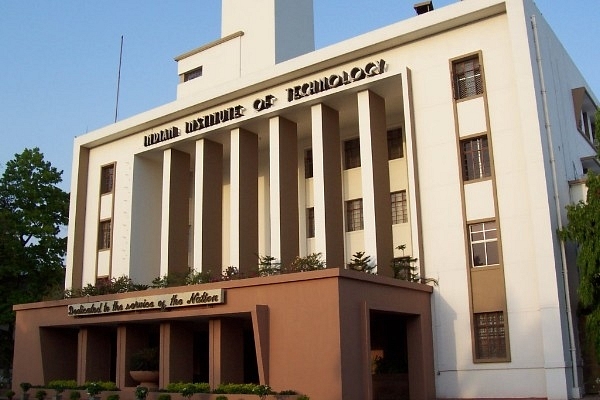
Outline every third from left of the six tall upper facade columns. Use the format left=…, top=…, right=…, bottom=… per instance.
left=229, top=128, right=258, bottom=273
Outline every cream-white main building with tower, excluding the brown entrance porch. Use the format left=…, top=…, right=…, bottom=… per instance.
left=14, top=0, right=598, bottom=399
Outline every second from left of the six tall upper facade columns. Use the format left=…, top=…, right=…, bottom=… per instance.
left=193, top=139, right=223, bottom=274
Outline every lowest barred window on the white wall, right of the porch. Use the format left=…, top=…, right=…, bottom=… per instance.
left=473, top=311, right=507, bottom=360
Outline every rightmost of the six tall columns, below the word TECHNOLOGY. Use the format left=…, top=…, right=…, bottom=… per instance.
left=357, top=90, right=394, bottom=276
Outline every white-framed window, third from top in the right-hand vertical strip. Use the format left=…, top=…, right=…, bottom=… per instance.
left=469, top=221, right=500, bottom=267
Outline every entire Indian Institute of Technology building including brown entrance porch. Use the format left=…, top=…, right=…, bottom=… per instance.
left=14, top=0, right=598, bottom=399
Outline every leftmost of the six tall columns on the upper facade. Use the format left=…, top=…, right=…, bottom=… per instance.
left=160, top=149, right=190, bottom=276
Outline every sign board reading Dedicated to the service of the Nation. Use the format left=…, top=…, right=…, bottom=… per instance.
left=67, top=289, right=225, bottom=317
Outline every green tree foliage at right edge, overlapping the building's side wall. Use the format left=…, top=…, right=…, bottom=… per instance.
left=558, top=168, right=600, bottom=356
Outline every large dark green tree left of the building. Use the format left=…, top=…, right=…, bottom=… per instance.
left=0, top=148, right=69, bottom=378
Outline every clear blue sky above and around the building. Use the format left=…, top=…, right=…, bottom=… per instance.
left=0, top=0, right=600, bottom=191
